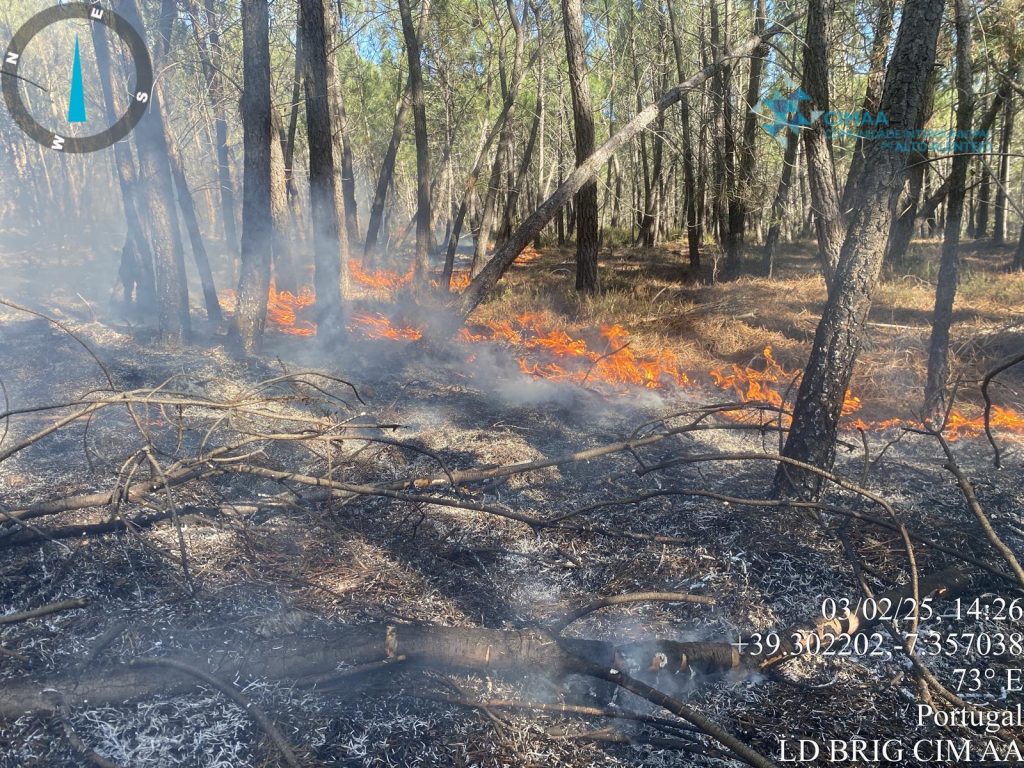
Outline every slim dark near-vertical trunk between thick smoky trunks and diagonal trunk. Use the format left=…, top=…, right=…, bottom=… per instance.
left=398, top=0, right=432, bottom=285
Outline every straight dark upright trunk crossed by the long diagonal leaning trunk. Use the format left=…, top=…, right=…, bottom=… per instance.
left=562, top=0, right=600, bottom=293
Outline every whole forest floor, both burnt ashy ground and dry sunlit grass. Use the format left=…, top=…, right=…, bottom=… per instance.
left=0, top=231, right=1024, bottom=768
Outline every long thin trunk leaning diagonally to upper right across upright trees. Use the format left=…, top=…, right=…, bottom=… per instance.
left=459, top=12, right=803, bottom=316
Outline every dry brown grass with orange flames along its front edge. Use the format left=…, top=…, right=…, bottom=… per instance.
left=224, top=240, right=1024, bottom=439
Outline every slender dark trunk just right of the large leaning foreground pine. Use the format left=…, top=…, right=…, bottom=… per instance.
left=925, top=0, right=974, bottom=426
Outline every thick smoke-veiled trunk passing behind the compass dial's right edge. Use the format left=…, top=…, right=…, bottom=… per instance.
left=122, top=0, right=189, bottom=343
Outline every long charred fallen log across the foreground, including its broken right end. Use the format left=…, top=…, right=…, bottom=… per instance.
left=0, top=567, right=972, bottom=718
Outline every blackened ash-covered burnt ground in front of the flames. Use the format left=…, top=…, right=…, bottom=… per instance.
left=0, top=231, right=1024, bottom=768
